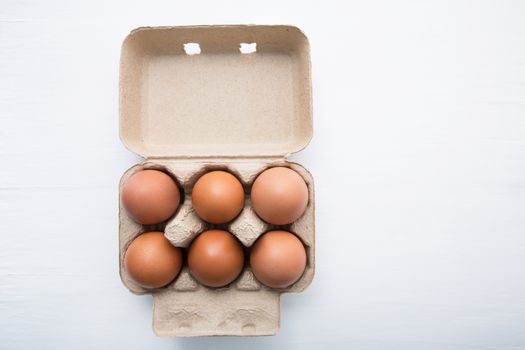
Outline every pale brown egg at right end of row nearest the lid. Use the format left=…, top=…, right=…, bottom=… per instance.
left=251, top=167, right=308, bottom=225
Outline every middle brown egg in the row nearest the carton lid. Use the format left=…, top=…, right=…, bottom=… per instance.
left=191, top=171, right=244, bottom=224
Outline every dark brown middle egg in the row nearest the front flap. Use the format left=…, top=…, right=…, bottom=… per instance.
left=188, top=230, right=244, bottom=287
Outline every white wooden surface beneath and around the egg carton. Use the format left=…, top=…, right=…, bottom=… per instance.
left=0, top=0, right=525, bottom=350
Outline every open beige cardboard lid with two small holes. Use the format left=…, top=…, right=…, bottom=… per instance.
left=120, top=25, right=312, bottom=158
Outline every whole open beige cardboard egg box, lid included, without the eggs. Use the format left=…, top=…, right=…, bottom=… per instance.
left=119, top=25, right=315, bottom=336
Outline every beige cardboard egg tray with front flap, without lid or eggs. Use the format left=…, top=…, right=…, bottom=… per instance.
left=119, top=160, right=315, bottom=336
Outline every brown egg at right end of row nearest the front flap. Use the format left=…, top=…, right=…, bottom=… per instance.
left=250, top=231, right=306, bottom=288
